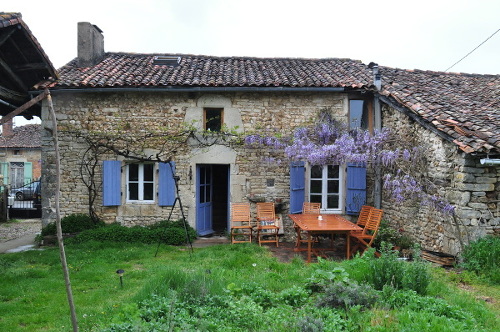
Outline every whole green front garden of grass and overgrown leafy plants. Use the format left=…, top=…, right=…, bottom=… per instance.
left=0, top=241, right=500, bottom=331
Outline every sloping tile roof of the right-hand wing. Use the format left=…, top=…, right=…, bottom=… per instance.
left=380, top=67, right=500, bottom=154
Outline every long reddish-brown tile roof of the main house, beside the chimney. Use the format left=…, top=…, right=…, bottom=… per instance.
left=48, top=53, right=372, bottom=88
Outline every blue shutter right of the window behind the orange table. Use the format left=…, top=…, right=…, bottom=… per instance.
left=346, top=163, right=366, bottom=215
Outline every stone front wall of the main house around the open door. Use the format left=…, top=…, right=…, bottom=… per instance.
left=42, top=91, right=348, bottom=239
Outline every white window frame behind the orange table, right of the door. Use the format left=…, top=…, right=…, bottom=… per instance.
left=306, top=164, right=346, bottom=214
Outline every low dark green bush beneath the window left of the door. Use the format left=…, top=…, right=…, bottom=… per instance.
left=67, top=220, right=196, bottom=246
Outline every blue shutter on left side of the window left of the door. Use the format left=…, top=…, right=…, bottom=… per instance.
left=102, top=160, right=122, bottom=206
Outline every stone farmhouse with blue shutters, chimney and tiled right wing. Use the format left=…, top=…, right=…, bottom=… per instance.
left=37, top=23, right=500, bottom=254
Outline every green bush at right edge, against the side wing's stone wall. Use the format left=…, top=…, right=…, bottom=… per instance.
left=462, top=236, right=500, bottom=284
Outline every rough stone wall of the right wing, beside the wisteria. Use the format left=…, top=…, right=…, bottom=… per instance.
left=383, top=106, right=500, bottom=254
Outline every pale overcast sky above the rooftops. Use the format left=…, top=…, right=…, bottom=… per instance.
left=4, top=0, right=500, bottom=125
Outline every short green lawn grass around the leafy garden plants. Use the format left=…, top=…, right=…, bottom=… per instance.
left=0, top=242, right=500, bottom=331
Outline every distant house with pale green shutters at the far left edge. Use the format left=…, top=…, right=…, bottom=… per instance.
left=0, top=121, right=42, bottom=188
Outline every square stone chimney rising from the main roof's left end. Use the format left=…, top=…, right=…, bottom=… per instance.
left=78, top=22, right=104, bottom=67
